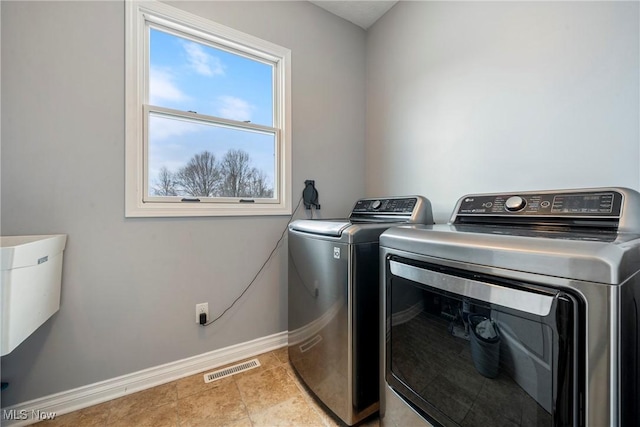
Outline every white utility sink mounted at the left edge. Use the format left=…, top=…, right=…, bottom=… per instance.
left=0, top=234, right=67, bottom=356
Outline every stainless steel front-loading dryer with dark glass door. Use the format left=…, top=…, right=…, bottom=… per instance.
left=380, top=188, right=640, bottom=427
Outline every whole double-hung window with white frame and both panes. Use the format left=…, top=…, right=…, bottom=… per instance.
left=125, top=1, right=291, bottom=217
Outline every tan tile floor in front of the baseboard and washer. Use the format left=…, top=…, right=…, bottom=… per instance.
left=37, top=347, right=379, bottom=427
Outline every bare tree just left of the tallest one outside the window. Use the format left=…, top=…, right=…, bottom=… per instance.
left=175, top=151, right=222, bottom=197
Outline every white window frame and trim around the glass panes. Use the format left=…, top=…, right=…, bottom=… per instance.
left=125, top=1, right=292, bottom=217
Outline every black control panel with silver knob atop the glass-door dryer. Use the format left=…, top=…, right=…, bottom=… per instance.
left=455, top=190, right=623, bottom=218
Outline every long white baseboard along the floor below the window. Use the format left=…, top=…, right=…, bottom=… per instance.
left=1, top=331, right=288, bottom=426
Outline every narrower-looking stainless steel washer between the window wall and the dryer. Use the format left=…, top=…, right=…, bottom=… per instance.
left=288, top=196, right=432, bottom=425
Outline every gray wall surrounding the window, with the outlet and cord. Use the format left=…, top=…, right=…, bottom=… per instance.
left=0, top=1, right=365, bottom=407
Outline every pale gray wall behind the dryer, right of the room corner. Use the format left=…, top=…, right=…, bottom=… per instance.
left=366, top=1, right=640, bottom=222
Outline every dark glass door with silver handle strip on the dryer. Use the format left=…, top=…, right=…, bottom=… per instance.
left=384, top=257, right=581, bottom=426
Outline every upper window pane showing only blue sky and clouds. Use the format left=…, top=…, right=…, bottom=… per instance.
left=149, top=28, right=274, bottom=126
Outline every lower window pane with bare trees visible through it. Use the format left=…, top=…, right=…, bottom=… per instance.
left=147, top=112, right=276, bottom=199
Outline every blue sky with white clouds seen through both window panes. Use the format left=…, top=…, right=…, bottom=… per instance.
left=149, top=28, right=275, bottom=192
